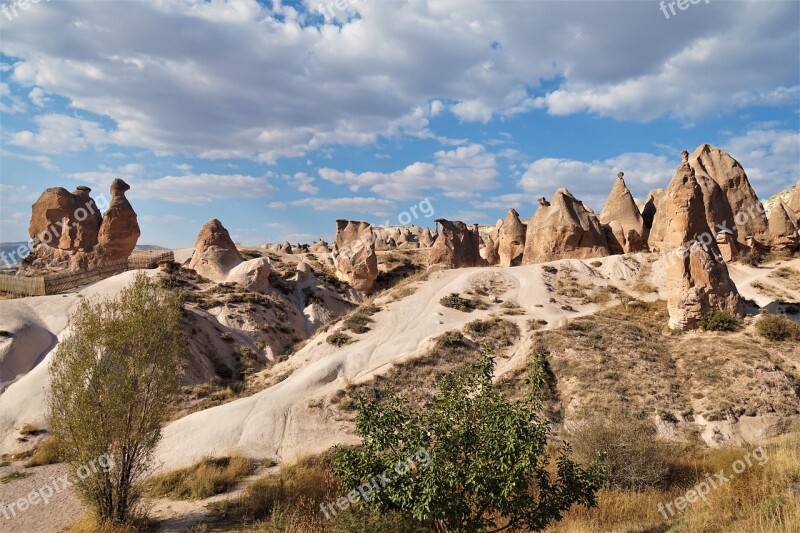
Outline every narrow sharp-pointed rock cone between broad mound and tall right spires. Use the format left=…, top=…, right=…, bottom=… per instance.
left=599, top=172, right=647, bottom=254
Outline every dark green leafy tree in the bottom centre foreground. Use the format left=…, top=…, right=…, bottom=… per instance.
left=334, top=352, right=602, bottom=533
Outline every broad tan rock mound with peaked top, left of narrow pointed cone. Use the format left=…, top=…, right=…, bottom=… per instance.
left=522, top=189, right=611, bottom=265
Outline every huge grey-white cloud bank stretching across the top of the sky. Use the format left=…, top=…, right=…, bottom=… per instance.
left=0, top=0, right=800, bottom=162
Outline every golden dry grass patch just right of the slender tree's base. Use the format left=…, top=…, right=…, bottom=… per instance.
left=144, top=456, right=255, bottom=500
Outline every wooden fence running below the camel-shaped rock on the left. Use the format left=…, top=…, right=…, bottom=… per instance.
left=0, top=251, right=175, bottom=296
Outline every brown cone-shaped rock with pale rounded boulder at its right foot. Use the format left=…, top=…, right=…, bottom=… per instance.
left=189, top=218, right=271, bottom=292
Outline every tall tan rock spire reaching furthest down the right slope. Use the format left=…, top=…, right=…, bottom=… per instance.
left=664, top=151, right=744, bottom=330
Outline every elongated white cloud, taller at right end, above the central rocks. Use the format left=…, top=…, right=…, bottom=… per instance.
left=319, top=144, right=499, bottom=200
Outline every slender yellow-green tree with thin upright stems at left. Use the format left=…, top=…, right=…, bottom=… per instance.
left=49, top=273, right=184, bottom=523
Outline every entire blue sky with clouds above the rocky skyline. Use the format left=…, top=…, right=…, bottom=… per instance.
left=0, top=0, right=800, bottom=247
